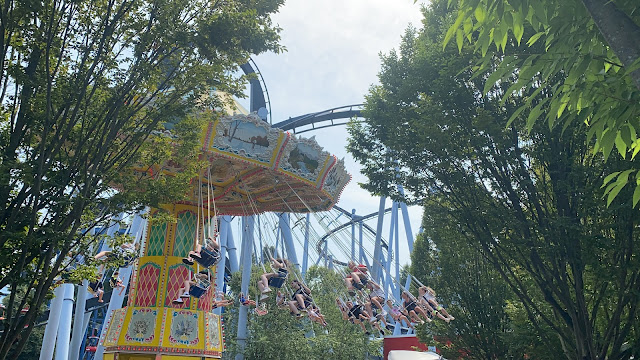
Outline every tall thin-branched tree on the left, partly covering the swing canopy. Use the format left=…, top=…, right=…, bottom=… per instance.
left=0, top=0, right=283, bottom=358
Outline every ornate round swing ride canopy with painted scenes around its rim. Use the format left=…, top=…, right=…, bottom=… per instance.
left=137, top=114, right=351, bottom=215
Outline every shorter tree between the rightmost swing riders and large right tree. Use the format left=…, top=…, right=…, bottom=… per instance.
left=411, top=217, right=510, bottom=359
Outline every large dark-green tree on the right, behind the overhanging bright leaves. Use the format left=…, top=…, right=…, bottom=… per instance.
left=348, top=1, right=640, bottom=359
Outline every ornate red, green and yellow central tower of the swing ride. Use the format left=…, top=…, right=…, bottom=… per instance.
left=102, top=204, right=224, bottom=360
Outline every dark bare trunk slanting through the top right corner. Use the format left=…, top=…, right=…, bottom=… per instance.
left=582, top=0, right=640, bottom=90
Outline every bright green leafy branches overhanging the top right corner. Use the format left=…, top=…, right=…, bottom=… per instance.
left=445, top=0, right=640, bottom=202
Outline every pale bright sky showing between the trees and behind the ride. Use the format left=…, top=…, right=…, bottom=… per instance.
left=238, top=0, right=422, bottom=263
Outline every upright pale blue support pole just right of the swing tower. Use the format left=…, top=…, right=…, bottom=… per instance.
left=235, top=216, right=255, bottom=360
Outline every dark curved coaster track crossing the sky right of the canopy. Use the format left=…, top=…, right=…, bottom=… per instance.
left=273, top=104, right=363, bottom=134
